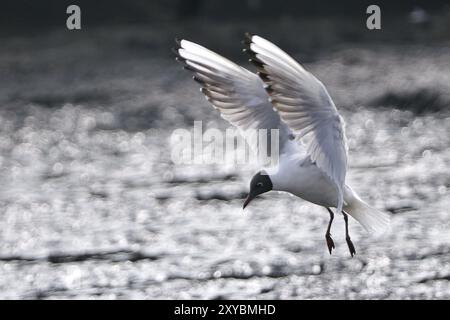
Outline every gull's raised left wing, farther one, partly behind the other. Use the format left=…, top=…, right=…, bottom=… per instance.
left=176, top=40, right=293, bottom=158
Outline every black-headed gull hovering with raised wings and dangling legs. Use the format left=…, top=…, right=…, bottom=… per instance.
left=176, top=34, right=389, bottom=256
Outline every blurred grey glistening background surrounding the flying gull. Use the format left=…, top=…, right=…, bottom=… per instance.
left=0, top=0, right=450, bottom=299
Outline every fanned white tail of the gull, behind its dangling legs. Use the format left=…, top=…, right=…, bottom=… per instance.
left=344, top=194, right=390, bottom=234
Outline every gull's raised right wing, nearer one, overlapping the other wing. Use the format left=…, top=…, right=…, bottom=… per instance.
left=245, top=35, right=347, bottom=212
